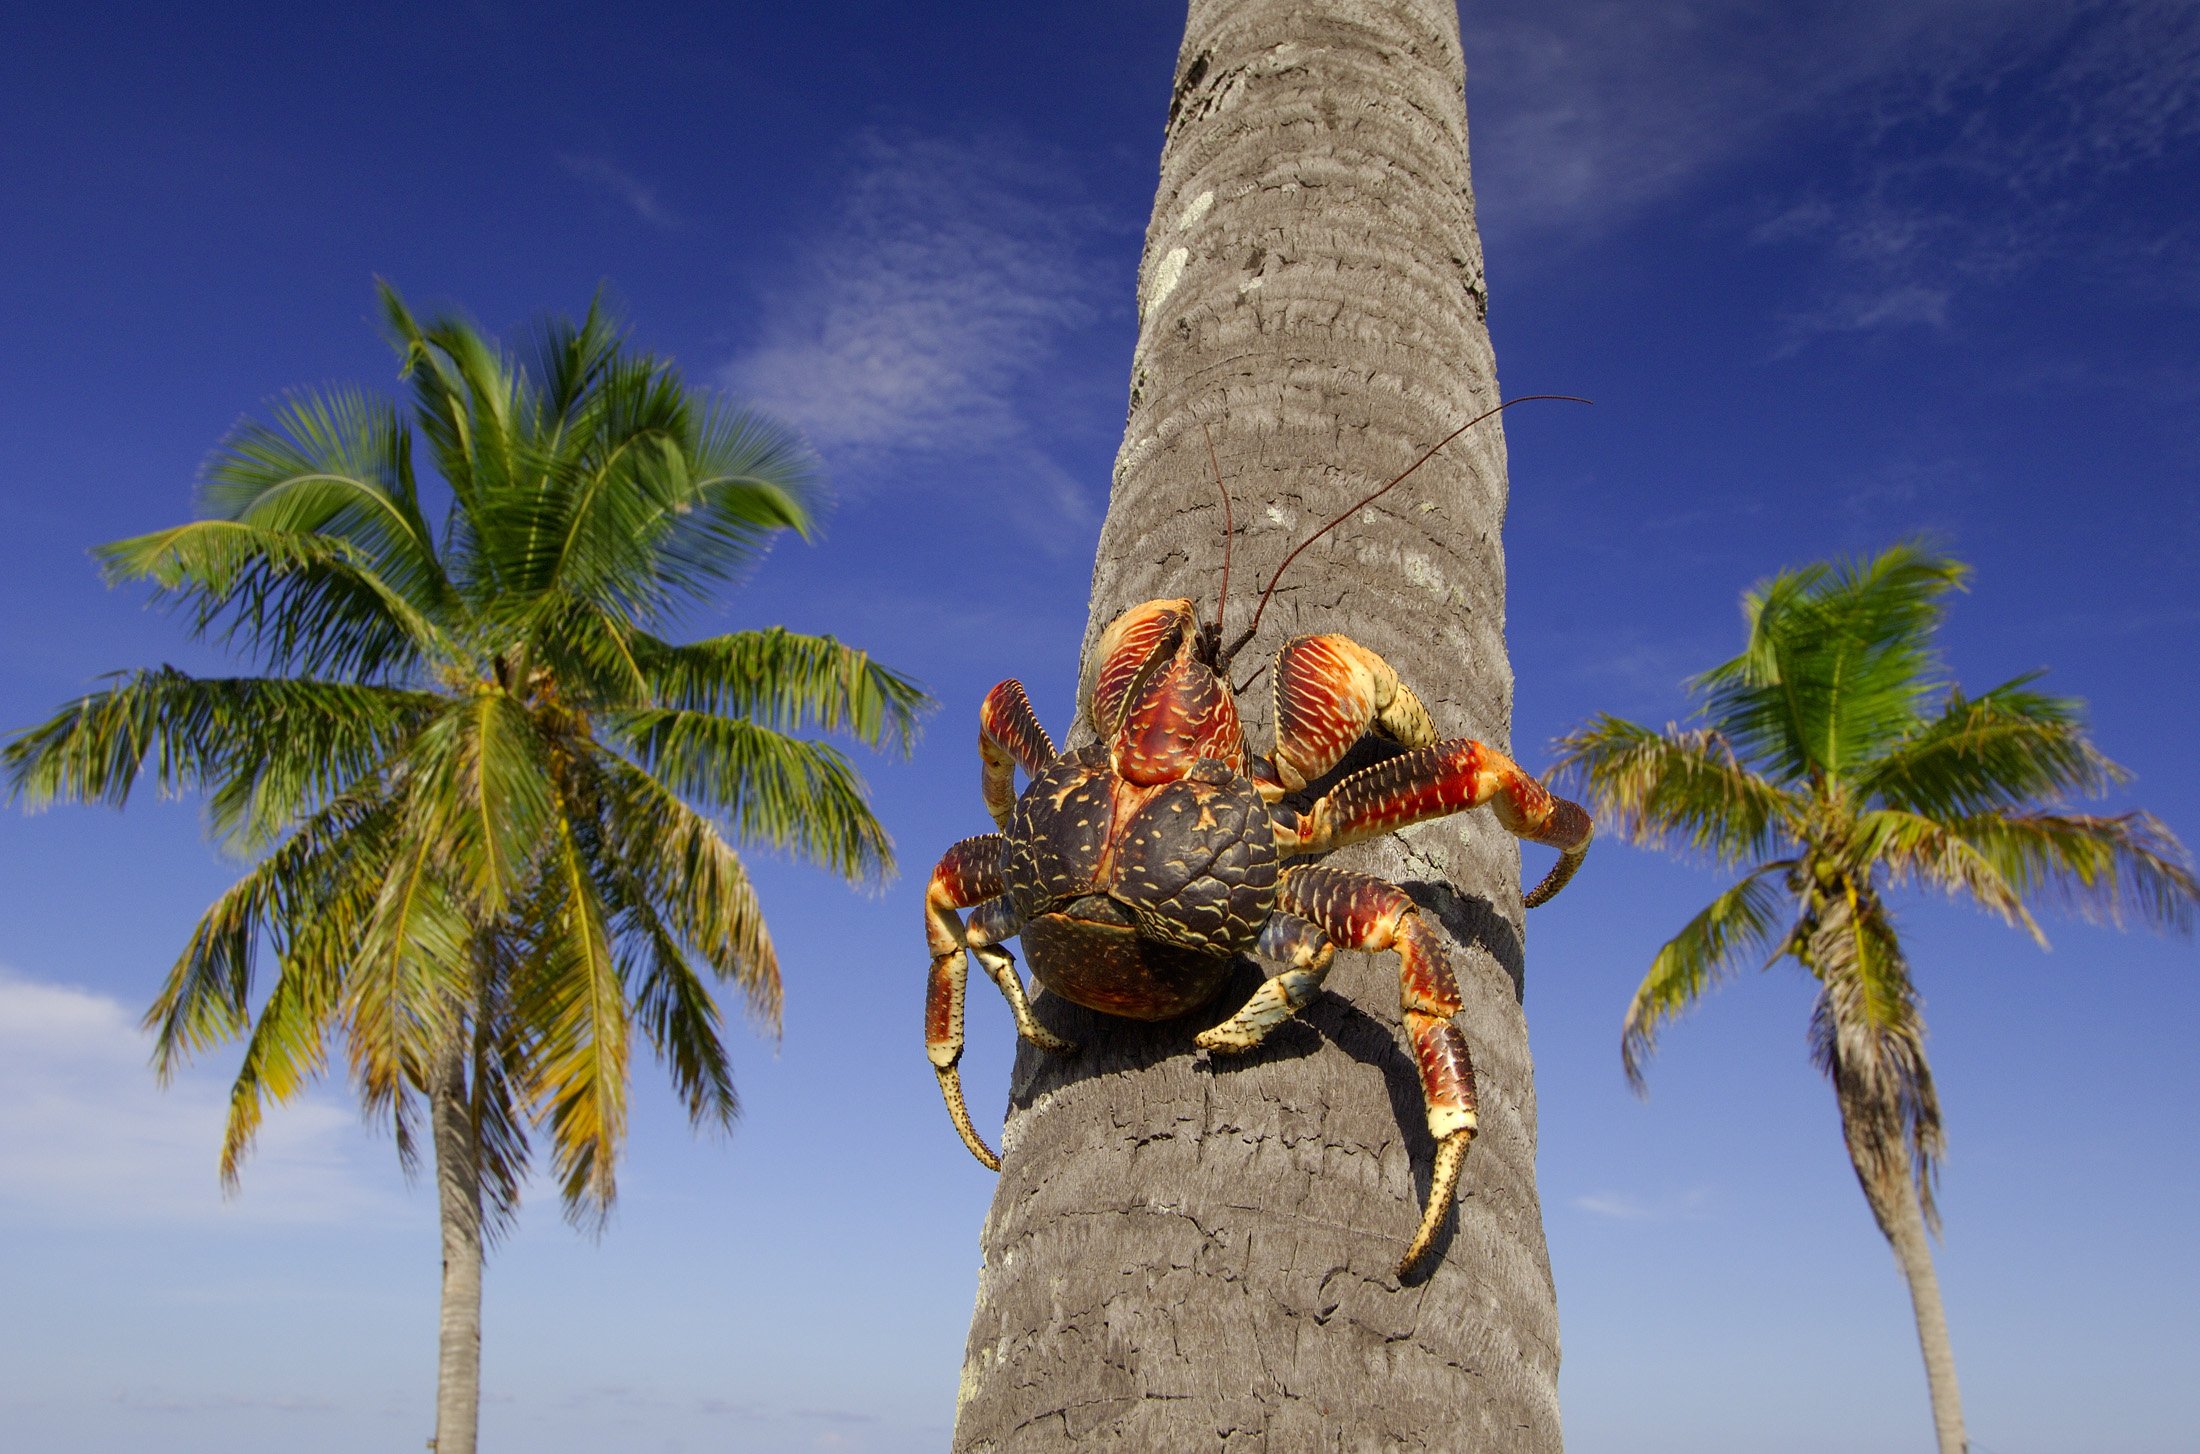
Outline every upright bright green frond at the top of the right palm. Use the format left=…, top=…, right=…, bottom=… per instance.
left=1694, top=541, right=1969, bottom=783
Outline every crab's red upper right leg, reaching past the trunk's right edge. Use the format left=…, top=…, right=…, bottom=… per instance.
left=1278, top=737, right=1595, bottom=908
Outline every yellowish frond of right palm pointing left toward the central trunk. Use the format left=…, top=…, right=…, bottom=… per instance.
left=1553, top=715, right=1800, bottom=862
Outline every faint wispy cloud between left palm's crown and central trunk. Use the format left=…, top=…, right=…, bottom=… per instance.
left=722, top=134, right=1104, bottom=549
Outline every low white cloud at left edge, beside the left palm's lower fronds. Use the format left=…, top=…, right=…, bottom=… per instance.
left=0, top=970, right=403, bottom=1225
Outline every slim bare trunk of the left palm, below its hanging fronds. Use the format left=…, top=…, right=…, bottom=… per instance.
left=429, top=1045, right=482, bottom=1454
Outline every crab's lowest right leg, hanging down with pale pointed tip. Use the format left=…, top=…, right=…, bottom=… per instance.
left=1276, top=864, right=1474, bottom=1278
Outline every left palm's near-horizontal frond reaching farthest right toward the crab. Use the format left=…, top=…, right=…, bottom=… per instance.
left=636, top=627, right=935, bottom=757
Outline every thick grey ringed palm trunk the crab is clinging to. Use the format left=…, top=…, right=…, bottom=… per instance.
left=955, top=0, right=1560, bottom=1454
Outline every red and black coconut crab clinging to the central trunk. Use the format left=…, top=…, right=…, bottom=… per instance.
left=924, top=400, right=1593, bottom=1276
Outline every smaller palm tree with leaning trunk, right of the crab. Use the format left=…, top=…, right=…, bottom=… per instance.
left=1560, top=543, right=2200, bottom=1454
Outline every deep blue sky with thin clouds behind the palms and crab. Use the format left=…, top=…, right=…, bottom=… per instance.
left=0, top=0, right=2200, bottom=1454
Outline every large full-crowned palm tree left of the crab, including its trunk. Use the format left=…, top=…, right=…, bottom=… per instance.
left=4, top=286, right=924, bottom=1454
